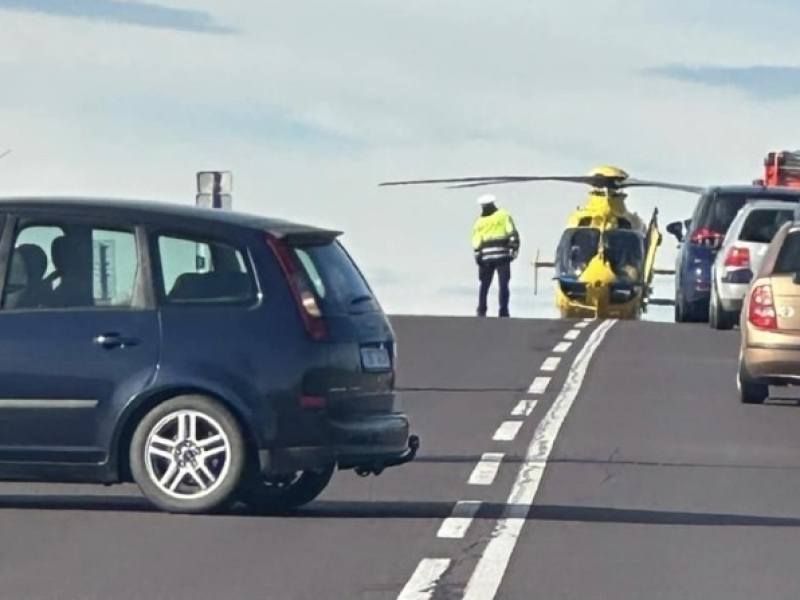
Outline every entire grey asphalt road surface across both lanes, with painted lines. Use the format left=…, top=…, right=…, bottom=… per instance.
left=0, top=317, right=800, bottom=600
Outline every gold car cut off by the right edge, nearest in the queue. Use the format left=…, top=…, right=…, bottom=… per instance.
left=736, top=221, right=800, bottom=404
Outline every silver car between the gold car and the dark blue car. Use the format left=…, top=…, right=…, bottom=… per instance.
left=708, top=200, right=797, bottom=329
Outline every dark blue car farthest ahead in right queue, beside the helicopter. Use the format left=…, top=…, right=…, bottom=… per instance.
left=667, top=185, right=800, bottom=323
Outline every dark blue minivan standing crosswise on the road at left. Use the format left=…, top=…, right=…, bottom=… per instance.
left=0, top=198, right=419, bottom=513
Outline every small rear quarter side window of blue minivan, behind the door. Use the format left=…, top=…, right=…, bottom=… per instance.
left=157, top=235, right=257, bottom=306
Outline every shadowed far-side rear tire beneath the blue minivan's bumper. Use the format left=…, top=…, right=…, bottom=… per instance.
left=238, top=463, right=336, bottom=512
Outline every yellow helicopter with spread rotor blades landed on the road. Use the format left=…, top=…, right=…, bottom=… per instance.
left=379, top=166, right=705, bottom=319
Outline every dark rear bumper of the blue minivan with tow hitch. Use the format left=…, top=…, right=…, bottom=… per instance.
left=258, top=413, right=419, bottom=475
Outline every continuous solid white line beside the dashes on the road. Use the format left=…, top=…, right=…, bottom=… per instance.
left=462, top=319, right=616, bottom=600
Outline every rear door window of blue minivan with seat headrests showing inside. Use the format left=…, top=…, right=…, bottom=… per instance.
left=2, top=222, right=139, bottom=310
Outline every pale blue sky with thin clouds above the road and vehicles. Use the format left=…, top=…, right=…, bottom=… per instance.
left=0, top=0, right=800, bottom=314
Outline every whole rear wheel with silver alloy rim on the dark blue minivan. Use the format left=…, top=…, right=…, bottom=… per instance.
left=130, top=396, right=246, bottom=513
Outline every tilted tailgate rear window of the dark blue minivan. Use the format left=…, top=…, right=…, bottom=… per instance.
left=292, top=240, right=375, bottom=313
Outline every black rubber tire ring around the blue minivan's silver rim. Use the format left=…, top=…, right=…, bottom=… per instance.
left=129, top=395, right=247, bottom=514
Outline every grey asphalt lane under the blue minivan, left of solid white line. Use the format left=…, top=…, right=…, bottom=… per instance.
left=0, top=317, right=585, bottom=600
